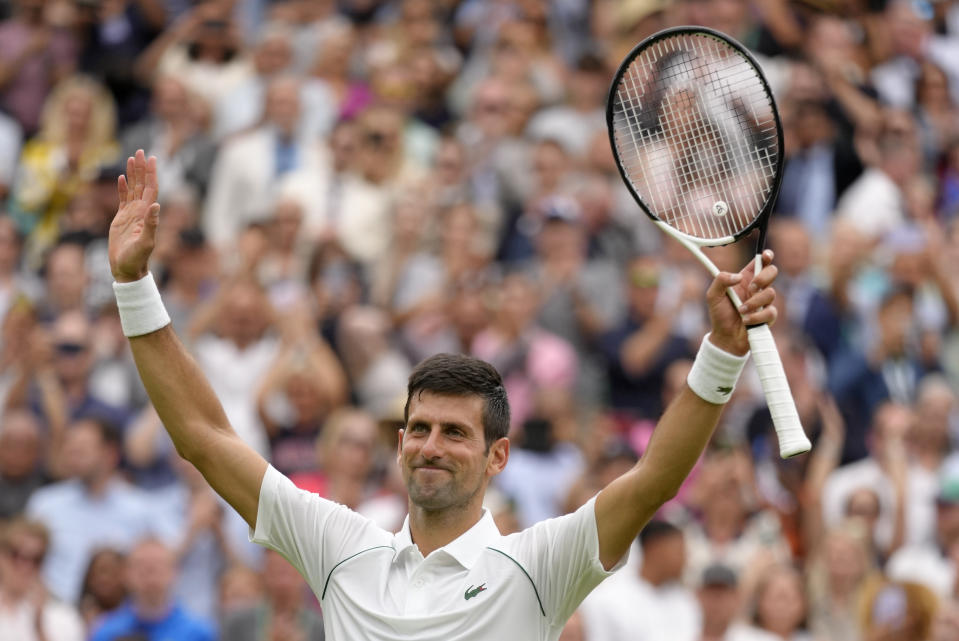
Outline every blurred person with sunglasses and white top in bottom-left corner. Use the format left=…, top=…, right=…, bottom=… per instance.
left=0, top=518, right=85, bottom=641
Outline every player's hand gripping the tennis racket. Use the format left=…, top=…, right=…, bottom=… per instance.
left=706, top=249, right=779, bottom=355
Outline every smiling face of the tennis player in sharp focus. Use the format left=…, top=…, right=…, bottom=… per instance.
left=398, top=391, right=509, bottom=512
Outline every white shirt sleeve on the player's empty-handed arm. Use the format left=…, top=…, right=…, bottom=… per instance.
left=250, top=465, right=393, bottom=591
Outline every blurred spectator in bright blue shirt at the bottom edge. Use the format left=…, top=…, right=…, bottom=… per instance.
left=90, top=539, right=216, bottom=641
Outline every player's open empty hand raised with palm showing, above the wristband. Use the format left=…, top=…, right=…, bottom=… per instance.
left=109, top=149, right=160, bottom=283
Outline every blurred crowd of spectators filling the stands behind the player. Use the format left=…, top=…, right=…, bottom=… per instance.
left=0, top=0, right=959, bottom=641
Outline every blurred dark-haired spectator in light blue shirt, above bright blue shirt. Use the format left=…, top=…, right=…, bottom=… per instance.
left=27, top=419, right=172, bottom=603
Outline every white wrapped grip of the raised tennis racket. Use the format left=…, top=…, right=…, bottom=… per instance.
left=746, top=324, right=812, bottom=458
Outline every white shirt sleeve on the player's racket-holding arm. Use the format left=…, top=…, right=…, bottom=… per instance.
left=507, top=497, right=629, bottom=624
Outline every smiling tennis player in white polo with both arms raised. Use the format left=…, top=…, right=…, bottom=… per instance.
left=110, top=151, right=776, bottom=641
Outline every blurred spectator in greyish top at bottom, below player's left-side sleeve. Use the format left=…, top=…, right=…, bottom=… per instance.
left=219, top=550, right=325, bottom=641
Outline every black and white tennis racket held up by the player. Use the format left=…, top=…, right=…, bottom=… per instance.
left=606, top=27, right=810, bottom=458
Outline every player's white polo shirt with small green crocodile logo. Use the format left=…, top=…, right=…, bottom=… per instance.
left=251, top=466, right=625, bottom=641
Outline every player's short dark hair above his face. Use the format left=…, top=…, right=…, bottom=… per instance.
left=403, top=354, right=509, bottom=449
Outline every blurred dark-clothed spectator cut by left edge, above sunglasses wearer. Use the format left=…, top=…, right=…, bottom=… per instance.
left=0, top=409, right=48, bottom=522
